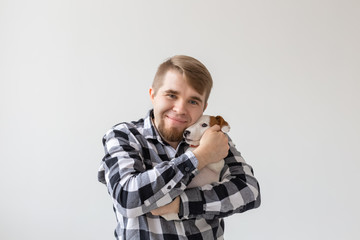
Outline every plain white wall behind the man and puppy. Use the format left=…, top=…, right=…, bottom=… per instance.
left=0, top=0, right=360, bottom=240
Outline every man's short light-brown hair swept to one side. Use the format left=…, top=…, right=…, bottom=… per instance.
left=152, top=55, right=213, bottom=104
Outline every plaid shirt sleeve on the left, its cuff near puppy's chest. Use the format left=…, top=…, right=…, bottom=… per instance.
left=98, top=125, right=198, bottom=218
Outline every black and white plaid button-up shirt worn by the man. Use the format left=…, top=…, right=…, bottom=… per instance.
left=98, top=111, right=260, bottom=240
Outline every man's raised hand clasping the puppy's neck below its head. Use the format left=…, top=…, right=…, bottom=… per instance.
left=193, top=125, right=230, bottom=170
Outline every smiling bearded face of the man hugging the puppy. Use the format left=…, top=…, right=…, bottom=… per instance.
left=150, top=70, right=206, bottom=147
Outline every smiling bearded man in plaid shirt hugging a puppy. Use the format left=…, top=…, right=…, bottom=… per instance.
left=99, top=56, right=260, bottom=240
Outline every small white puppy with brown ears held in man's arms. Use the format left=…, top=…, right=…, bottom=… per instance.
left=162, top=115, right=230, bottom=221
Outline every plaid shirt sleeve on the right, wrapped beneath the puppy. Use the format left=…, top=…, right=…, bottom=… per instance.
left=179, top=135, right=261, bottom=219
